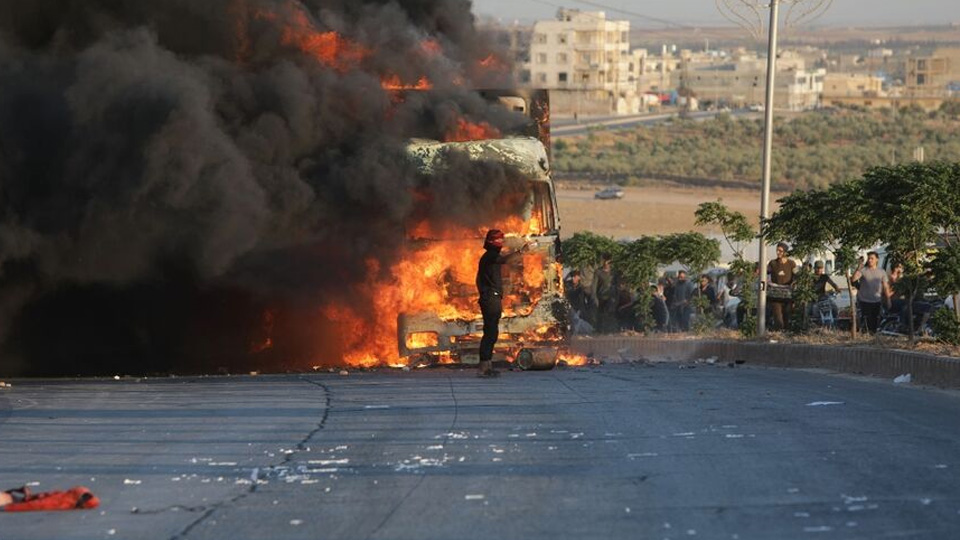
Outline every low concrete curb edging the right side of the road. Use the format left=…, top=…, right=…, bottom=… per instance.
left=570, top=336, right=960, bottom=388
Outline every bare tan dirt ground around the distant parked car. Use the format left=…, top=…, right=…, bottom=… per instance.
left=557, top=182, right=782, bottom=239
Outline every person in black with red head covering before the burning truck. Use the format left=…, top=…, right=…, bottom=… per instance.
left=477, top=229, right=529, bottom=377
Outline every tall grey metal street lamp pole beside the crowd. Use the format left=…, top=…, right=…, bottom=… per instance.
left=757, top=0, right=780, bottom=336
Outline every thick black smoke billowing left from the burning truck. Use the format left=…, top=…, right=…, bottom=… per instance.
left=0, top=0, right=520, bottom=374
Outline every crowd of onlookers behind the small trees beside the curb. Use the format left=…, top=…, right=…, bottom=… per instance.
left=564, top=243, right=928, bottom=334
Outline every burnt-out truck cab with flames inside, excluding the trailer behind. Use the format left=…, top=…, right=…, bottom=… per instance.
left=397, top=132, right=569, bottom=368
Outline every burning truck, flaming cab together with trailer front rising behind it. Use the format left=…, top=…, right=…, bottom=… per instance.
left=347, top=91, right=570, bottom=369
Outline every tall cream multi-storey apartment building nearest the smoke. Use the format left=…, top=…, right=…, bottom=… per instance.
left=524, top=9, right=636, bottom=112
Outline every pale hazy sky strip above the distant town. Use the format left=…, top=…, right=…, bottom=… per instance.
left=473, top=0, right=960, bottom=26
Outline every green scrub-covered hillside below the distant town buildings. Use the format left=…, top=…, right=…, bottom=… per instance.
left=554, top=103, right=960, bottom=191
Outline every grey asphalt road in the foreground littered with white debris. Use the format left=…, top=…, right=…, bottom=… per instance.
left=0, top=364, right=960, bottom=540
